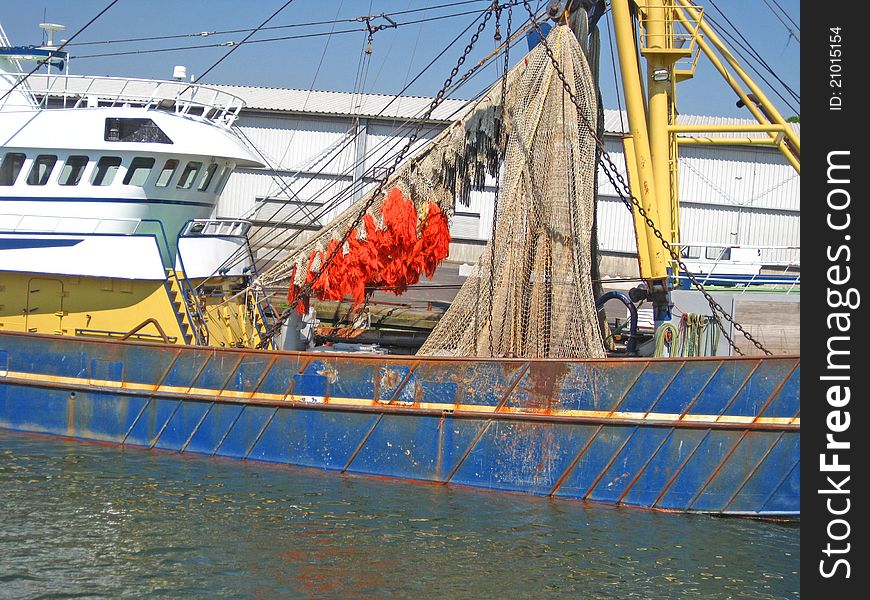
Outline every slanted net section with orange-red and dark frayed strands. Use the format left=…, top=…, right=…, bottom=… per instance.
left=258, top=56, right=521, bottom=302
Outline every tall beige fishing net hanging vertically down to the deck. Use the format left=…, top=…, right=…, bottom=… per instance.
left=419, top=26, right=604, bottom=357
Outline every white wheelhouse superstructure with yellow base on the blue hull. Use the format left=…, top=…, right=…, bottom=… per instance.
left=0, top=35, right=272, bottom=346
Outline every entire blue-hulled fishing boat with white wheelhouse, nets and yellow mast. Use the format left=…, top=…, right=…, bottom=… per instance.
left=0, top=0, right=800, bottom=517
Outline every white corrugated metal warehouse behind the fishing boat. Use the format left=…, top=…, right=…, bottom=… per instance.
left=213, top=86, right=800, bottom=276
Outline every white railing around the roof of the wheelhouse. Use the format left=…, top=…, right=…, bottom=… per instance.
left=0, top=74, right=245, bottom=127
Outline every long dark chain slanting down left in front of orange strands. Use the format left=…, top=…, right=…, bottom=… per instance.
left=257, top=7, right=494, bottom=348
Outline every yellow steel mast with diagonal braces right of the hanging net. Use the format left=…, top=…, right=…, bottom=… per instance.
left=611, top=0, right=800, bottom=308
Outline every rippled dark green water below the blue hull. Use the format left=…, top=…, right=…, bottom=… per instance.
left=0, top=431, right=800, bottom=599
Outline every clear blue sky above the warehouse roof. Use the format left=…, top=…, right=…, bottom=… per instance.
left=0, top=0, right=800, bottom=118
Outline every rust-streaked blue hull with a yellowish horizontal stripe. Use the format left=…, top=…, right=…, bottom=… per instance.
left=0, top=333, right=800, bottom=517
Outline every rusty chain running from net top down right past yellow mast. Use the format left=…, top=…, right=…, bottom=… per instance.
left=523, top=0, right=773, bottom=356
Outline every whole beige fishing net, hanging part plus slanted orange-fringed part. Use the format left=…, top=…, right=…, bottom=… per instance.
left=260, top=26, right=604, bottom=357
